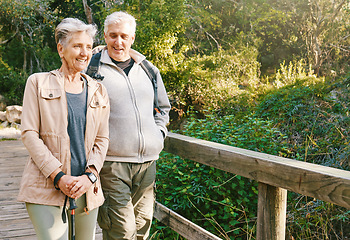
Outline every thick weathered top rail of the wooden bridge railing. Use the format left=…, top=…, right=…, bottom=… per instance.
left=164, top=133, right=350, bottom=208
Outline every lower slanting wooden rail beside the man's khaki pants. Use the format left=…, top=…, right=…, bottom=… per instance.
left=154, top=202, right=221, bottom=240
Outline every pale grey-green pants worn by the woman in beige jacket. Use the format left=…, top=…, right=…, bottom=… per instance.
left=26, top=194, right=98, bottom=240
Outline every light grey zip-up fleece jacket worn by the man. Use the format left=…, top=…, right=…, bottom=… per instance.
left=100, top=48, right=170, bottom=163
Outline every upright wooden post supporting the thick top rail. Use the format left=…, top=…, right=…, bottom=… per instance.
left=256, top=182, right=287, bottom=240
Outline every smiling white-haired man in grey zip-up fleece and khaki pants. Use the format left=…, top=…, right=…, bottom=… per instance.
left=88, top=12, right=170, bottom=239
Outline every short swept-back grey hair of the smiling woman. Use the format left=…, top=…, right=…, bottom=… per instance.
left=55, top=18, right=97, bottom=46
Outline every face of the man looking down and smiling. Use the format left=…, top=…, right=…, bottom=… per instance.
left=104, top=22, right=135, bottom=62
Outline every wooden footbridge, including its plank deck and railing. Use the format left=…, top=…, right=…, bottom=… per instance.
left=0, top=133, right=350, bottom=240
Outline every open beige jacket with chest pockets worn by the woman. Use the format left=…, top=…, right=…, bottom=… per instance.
left=18, top=70, right=110, bottom=210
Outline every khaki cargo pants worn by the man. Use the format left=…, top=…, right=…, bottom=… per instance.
left=98, top=161, right=156, bottom=240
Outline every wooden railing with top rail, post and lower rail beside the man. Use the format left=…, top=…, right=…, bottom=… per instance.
left=154, top=133, right=350, bottom=240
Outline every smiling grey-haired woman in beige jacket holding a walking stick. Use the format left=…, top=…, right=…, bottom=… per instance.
left=18, top=18, right=109, bottom=240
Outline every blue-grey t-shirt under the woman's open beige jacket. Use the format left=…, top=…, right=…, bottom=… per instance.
left=66, top=78, right=87, bottom=176
